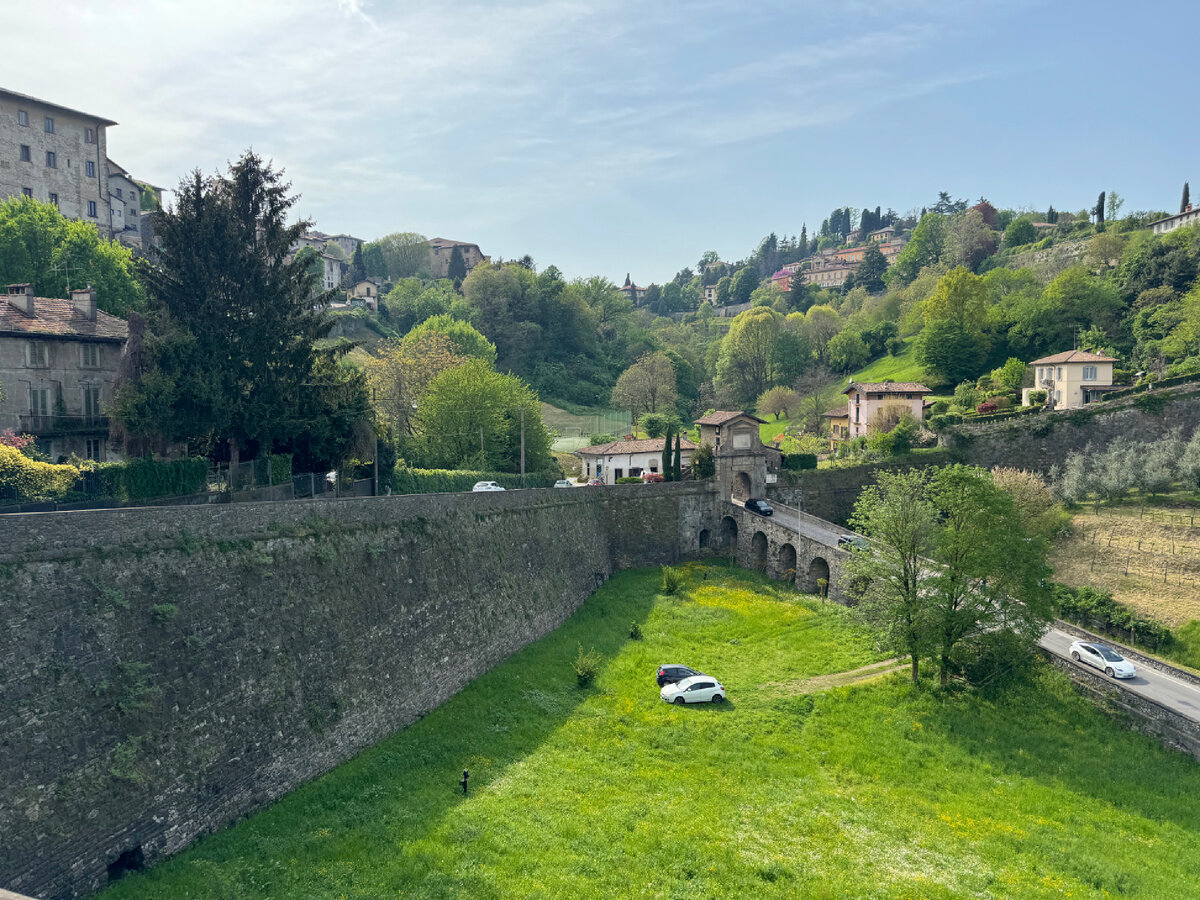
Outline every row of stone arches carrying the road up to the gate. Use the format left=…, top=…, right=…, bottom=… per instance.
left=701, top=500, right=850, bottom=602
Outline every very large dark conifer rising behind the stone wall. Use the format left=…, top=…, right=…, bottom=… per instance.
left=113, top=151, right=365, bottom=462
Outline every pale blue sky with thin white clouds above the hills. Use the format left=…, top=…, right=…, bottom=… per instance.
left=9, top=0, right=1200, bottom=284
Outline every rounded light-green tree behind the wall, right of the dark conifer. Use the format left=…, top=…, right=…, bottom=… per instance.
left=415, top=359, right=553, bottom=472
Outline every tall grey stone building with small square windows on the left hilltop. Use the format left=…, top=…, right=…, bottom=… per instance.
left=0, top=88, right=149, bottom=247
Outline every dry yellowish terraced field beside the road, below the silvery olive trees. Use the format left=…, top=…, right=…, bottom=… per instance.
left=1050, top=505, right=1200, bottom=628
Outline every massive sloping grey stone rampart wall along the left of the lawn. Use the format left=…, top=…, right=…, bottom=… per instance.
left=0, top=485, right=714, bottom=898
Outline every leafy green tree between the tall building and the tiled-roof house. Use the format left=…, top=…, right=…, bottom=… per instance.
left=0, top=197, right=146, bottom=318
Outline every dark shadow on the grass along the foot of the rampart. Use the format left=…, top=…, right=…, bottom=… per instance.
left=104, top=570, right=672, bottom=898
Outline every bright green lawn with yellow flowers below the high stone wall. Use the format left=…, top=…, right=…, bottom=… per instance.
left=104, top=564, right=1200, bottom=900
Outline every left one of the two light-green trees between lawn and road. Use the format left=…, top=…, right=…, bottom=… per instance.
left=845, top=469, right=937, bottom=684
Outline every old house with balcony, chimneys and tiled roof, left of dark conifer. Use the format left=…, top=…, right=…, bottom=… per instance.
left=0, top=284, right=130, bottom=460
